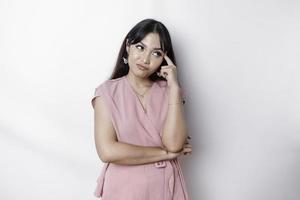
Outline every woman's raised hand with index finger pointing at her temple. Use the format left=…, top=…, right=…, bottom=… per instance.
left=157, top=54, right=178, bottom=87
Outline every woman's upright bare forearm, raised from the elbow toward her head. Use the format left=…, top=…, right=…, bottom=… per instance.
left=162, top=86, right=187, bottom=152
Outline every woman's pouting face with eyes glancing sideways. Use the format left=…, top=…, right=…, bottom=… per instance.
left=126, top=33, right=164, bottom=78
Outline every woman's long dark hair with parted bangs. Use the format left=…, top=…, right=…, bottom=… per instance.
left=110, top=19, right=180, bottom=86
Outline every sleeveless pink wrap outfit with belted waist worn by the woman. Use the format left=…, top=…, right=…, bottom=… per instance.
left=91, top=76, right=189, bottom=200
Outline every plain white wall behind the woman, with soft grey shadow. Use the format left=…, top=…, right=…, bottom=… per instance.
left=0, top=0, right=300, bottom=200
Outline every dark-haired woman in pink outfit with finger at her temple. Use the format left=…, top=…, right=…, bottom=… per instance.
left=92, top=19, right=192, bottom=200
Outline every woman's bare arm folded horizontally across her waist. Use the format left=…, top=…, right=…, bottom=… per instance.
left=94, top=97, right=169, bottom=165
